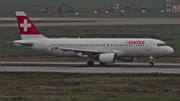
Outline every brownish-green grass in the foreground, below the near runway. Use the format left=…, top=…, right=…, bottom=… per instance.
left=0, top=72, right=180, bottom=101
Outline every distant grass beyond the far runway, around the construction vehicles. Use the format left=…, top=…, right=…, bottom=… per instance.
left=0, top=0, right=180, bottom=17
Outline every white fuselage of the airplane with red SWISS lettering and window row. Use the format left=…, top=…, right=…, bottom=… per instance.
left=16, top=38, right=174, bottom=57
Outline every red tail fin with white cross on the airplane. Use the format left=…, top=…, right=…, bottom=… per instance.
left=16, top=11, right=41, bottom=35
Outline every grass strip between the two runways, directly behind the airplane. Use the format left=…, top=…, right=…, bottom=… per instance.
left=0, top=25, right=180, bottom=62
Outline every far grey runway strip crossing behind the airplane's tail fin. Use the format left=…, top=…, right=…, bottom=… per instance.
left=0, top=17, right=180, bottom=27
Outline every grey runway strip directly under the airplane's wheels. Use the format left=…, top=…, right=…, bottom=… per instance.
left=0, top=62, right=180, bottom=74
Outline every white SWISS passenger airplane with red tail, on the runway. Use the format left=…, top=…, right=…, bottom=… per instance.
left=13, top=11, right=174, bottom=66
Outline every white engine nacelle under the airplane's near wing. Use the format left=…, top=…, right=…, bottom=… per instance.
left=99, top=53, right=117, bottom=63
